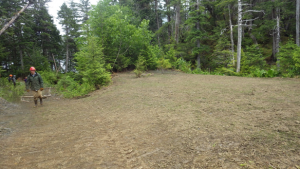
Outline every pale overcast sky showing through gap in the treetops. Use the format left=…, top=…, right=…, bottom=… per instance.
left=48, top=0, right=99, bottom=34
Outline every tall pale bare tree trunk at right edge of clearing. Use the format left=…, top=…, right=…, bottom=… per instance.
left=236, top=0, right=242, bottom=73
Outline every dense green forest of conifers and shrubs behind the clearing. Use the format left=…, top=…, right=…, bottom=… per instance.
left=0, top=0, right=300, bottom=96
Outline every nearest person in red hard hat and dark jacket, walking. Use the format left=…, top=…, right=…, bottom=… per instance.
left=26, top=67, right=44, bottom=107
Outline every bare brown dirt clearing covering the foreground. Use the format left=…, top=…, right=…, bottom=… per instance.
left=0, top=72, right=300, bottom=169
